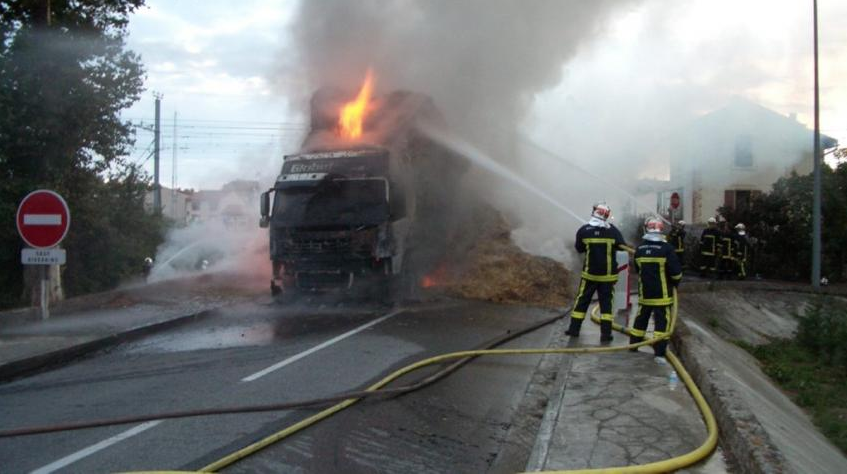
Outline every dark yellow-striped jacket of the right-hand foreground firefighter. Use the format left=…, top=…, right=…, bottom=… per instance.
left=635, top=234, right=682, bottom=306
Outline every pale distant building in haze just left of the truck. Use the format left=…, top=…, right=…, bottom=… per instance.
left=187, top=180, right=259, bottom=229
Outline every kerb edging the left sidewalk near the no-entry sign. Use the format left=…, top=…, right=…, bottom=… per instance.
left=0, top=309, right=214, bottom=383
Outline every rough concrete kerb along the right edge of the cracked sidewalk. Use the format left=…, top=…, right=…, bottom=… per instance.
left=672, top=320, right=793, bottom=474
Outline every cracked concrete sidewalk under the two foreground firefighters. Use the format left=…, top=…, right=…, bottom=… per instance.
left=526, top=310, right=728, bottom=473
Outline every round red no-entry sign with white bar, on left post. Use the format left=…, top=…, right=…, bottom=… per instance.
left=16, top=189, right=71, bottom=249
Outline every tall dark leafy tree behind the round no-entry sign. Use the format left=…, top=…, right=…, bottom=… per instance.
left=0, top=0, right=161, bottom=306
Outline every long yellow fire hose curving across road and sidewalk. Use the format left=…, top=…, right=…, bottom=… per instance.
left=189, top=293, right=718, bottom=474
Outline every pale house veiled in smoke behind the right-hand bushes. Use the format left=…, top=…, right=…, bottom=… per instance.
left=659, top=99, right=838, bottom=222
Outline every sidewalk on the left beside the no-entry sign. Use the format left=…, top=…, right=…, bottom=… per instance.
left=0, top=275, right=264, bottom=381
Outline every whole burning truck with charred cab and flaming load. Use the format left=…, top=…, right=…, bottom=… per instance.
left=260, top=74, right=466, bottom=299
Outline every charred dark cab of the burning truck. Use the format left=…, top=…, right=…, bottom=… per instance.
left=260, top=147, right=408, bottom=296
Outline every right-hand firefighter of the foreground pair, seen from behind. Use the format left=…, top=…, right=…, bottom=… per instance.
left=629, top=219, right=682, bottom=361
